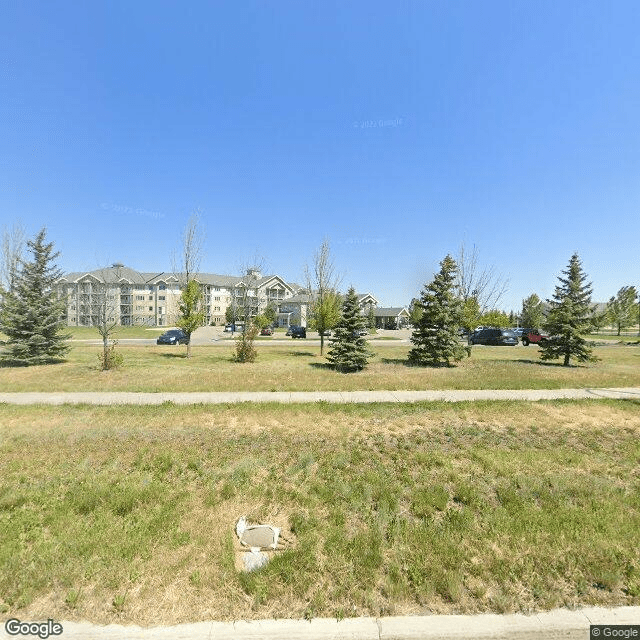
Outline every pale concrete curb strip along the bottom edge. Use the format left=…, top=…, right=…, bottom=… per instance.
left=0, top=607, right=640, bottom=640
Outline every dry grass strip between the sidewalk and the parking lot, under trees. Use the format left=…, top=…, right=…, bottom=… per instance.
left=0, top=343, right=640, bottom=392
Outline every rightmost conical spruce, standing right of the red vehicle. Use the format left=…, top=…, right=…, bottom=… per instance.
left=540, top=253, right=597, bottom=367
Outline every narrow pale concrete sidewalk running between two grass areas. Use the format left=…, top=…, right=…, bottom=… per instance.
left=0, top=387, right=640, bottom=405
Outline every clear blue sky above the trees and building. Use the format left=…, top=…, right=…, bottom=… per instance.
left=0, top=0, right=640, bottom=310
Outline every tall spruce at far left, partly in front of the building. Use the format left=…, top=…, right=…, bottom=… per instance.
left=1, top=228, right=70, bottom=366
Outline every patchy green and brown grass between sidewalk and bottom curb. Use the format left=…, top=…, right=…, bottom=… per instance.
left=0, top=401, right=640, bottom=625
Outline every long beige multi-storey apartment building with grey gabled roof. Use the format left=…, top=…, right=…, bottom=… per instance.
left=57, top=263, right=298, bottom=327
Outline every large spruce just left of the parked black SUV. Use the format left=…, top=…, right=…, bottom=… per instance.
left=409, top=256, right=469, bottom=367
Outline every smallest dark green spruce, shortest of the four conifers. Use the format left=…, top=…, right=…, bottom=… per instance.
left=327, top=287, right=373, bottom=373
